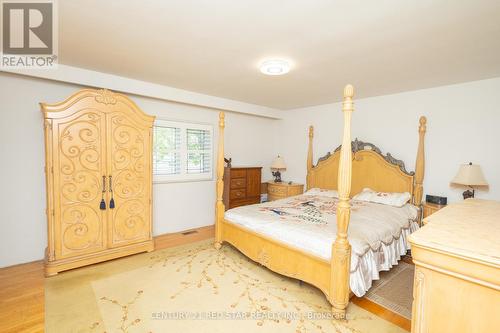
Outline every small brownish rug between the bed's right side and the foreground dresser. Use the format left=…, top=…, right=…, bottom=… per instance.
left=365, top=261, right=415, bottom=319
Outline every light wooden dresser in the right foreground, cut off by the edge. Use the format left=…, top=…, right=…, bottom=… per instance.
left=410, top=199, right=500, bottom=333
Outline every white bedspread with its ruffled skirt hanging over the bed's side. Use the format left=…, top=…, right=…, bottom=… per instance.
left=225, top=195, right=418, bottom=297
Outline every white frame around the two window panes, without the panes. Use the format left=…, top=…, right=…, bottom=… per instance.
left=151, top=118, right=215, bottom=184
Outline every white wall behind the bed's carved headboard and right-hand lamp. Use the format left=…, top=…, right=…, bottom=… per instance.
left=276, top=78, right=500, bottom=202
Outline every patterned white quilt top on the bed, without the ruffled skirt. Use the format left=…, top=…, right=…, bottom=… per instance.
left=225, top=195, right=418, bottom=259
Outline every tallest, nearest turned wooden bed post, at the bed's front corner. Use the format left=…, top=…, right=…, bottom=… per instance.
left=330, top=85, right=354, bottom=319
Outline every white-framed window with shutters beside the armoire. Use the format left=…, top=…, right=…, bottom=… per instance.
left=153, top=120, right=213, bottom=182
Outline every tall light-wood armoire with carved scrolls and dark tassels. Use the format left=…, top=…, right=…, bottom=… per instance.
left=40, top=89, right=155, bottom=276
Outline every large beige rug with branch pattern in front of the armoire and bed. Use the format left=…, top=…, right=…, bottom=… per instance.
left=45, top=241, right=405, bottom=333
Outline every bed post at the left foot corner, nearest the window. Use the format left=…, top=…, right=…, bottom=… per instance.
left=214, top=112, right=225, bottom=250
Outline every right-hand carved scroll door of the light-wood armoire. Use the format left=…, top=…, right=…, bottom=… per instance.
left=107, top=111, right=152, bottom=247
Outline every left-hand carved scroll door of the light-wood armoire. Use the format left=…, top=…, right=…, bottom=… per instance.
left=49, top=108, right=107, bottom=259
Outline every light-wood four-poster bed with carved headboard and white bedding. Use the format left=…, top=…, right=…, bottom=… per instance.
left=215, top=85, right=426, bottom=319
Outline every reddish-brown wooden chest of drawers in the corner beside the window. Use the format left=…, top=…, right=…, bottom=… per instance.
left=223, top=167, right=262, bottom=210
